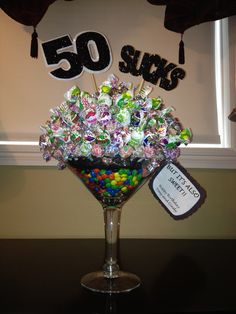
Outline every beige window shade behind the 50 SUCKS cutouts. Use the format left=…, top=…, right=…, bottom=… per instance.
left=0, top=0, right=216, bottom=140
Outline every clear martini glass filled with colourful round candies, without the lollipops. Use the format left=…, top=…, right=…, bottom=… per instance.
left=69, top=161, right=153, bottom=293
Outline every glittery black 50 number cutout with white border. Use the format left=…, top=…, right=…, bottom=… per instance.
left=42, top=31, right=112, bottom=80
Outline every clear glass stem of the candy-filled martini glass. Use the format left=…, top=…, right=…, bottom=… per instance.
left=103, top=206, right=121, bottom=279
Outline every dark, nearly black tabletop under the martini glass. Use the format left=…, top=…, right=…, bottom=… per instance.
left=0, top=239, right=236, bottom=314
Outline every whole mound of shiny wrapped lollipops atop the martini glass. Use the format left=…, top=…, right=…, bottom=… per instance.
left=39, top=74, right=192, bottom=169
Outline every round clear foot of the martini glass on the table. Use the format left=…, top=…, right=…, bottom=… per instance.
left=81, top=271, right=141, bottom=293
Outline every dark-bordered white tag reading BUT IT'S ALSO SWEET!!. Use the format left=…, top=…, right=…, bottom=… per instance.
left=149, top=162, right=206, bottom=219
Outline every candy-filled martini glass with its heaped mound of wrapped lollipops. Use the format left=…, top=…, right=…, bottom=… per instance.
left=39, top=75, right=192, bottom=293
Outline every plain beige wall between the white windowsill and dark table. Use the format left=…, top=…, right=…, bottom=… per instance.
left=0, top=166, right=236, bottom=238
